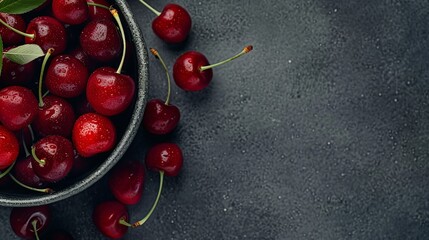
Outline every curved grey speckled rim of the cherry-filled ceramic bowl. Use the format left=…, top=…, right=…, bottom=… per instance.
left=0, top=0, right=149, bottom=207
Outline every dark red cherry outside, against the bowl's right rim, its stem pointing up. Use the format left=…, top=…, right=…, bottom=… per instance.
left=143, top=99, right=180, bottom=135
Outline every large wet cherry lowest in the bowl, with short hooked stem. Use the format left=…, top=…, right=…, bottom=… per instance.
left=31, top=135, right=74, bottom=182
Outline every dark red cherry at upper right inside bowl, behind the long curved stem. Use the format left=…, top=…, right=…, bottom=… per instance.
left=80, top=19, right=122, bottom=62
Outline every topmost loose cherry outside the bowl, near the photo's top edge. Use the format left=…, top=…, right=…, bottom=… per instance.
left=152, top=3, right=192, bottom=43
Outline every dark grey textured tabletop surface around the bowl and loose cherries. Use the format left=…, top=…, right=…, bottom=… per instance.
left=0, top=0, right=429, bottom=240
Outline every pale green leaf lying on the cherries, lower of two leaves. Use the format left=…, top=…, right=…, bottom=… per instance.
left=3, top=44, right=45, bottom=65
